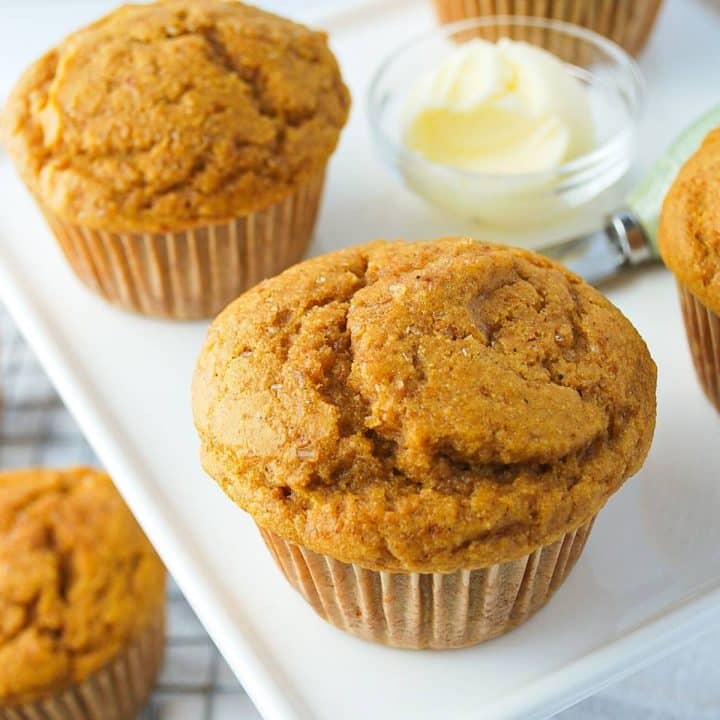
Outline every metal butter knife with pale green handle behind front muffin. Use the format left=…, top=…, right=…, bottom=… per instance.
left=542, top=105, right=720, bottom=283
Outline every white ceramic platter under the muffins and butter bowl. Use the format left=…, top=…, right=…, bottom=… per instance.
left=0, top=0, right=720, bottom=720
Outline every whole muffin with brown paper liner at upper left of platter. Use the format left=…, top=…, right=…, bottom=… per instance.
left=3, top=0, right=350, bottom=318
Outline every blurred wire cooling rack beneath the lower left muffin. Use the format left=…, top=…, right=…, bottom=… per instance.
left=0, top=306, right=259, bottom=720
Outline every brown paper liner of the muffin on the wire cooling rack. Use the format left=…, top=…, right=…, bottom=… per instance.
left=0, top=608, right=165, bottom=720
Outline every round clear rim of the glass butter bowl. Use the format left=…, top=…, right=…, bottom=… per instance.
left=366, top=15, right=646, bottom=182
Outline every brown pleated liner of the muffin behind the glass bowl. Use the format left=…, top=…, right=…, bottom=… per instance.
left=435, top=0, right=662, bottom=59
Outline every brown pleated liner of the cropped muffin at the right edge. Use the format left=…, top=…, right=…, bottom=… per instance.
left=678, top=283, right=720, bottom=412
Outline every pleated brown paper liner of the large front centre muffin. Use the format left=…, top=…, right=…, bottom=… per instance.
left=260, top=518, right=594, bottom=650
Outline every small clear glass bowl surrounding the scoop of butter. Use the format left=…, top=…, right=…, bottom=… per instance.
left=368, top=17, right=644, bottom=231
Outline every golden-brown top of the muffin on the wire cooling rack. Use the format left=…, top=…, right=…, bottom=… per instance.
left=0, top=468, right=165, bottom=704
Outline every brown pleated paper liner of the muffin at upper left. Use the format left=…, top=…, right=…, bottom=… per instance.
left=39, top=168, right=325, bottom=320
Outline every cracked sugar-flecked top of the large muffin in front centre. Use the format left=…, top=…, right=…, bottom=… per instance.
left=193, top=238, right=656, bottom=572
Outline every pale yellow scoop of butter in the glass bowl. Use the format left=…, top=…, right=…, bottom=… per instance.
left=405, top=38, right=594, bottom=175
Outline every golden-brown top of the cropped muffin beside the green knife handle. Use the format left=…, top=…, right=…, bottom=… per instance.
left=658, top=128, right=720, bottom=313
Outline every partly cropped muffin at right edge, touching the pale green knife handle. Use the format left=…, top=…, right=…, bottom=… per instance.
left=658, top=129, right=720, bottom=411
